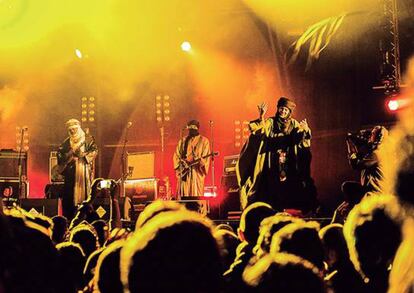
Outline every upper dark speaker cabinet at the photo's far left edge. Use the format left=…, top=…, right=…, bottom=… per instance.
left=0, top=150, right=27, bottom=179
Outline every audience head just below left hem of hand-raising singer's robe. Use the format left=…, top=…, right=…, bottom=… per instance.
left=237, top=202, right=275, bottom=245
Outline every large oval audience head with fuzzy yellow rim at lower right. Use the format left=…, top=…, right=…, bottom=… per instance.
left=344, top=195, right=401, bottom=282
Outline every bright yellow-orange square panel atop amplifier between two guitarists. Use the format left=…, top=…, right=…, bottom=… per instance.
left=126, top=152, right=155, bottom=179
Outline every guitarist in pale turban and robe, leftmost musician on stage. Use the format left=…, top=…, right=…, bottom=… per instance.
left=58, top=119, right=98, bottom=219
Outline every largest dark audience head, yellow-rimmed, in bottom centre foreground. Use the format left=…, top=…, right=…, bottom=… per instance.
left=121, top=210, right=222, bottom=293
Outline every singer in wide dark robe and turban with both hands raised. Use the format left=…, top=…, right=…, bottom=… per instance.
left=236, top=97, right=317, bottom=213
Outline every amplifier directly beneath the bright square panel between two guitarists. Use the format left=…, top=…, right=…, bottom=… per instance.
left=124, top=178, right=159, bottom=203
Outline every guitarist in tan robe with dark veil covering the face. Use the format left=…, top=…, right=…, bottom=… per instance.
left=173, top=120, right=211, bottom=197
